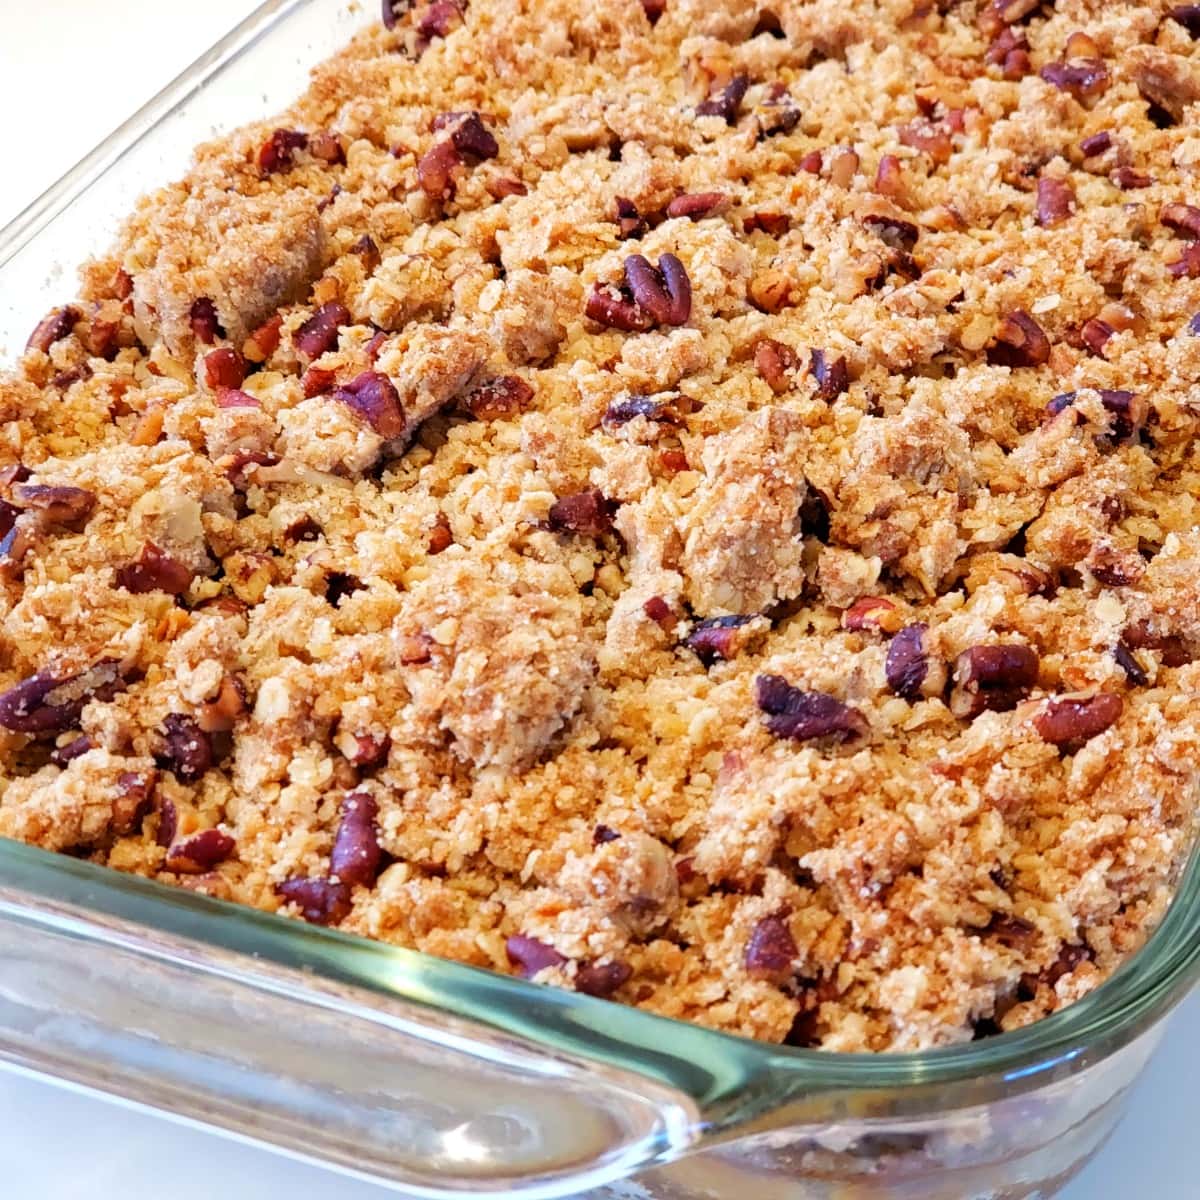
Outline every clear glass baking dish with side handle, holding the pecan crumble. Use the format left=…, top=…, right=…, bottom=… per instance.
left=0, top=0, right=1200, bottom=1200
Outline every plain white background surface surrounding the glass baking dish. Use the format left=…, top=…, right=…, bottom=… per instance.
left=0, top=0, right=1200, bottom=1200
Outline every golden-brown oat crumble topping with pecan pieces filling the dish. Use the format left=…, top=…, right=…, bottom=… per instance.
left=0, top=0, right=1200, bottom=1050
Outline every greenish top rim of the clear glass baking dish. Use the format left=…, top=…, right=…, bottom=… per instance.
left=0, top=0, right=1200, bottom=1128
